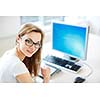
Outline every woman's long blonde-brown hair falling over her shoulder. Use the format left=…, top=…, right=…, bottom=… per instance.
left=16, top=23, right=44, bottom=76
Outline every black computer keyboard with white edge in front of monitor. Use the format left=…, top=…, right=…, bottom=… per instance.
left=43, top=55, right=81, bottom=72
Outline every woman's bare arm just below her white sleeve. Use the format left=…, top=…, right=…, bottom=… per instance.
left=16, top=73, right=33, bottom=83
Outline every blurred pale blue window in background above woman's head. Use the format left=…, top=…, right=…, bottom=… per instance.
left=20, top=16, right=64, bottom=32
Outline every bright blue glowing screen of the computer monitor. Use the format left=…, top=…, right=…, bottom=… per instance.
left=53, top=23, right=87, bottom=60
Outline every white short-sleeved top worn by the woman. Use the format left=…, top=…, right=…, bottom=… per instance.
left=0, top=48, right=29, bottom=83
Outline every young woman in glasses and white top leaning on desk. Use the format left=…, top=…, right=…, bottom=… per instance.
left=0, top=24, right=50, bottom=83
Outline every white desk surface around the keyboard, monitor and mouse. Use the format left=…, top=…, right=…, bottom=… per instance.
left=42, top=34, right=100, bottom=83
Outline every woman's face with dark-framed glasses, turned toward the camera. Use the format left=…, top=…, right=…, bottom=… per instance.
left=18, top=32, right=41, bottom=57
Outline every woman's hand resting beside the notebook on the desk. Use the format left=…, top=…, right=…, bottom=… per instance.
left=41, top=67, right=50, bottom=83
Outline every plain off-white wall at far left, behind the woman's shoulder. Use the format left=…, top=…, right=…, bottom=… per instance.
left=0, top=16, right=20, bottom=56
